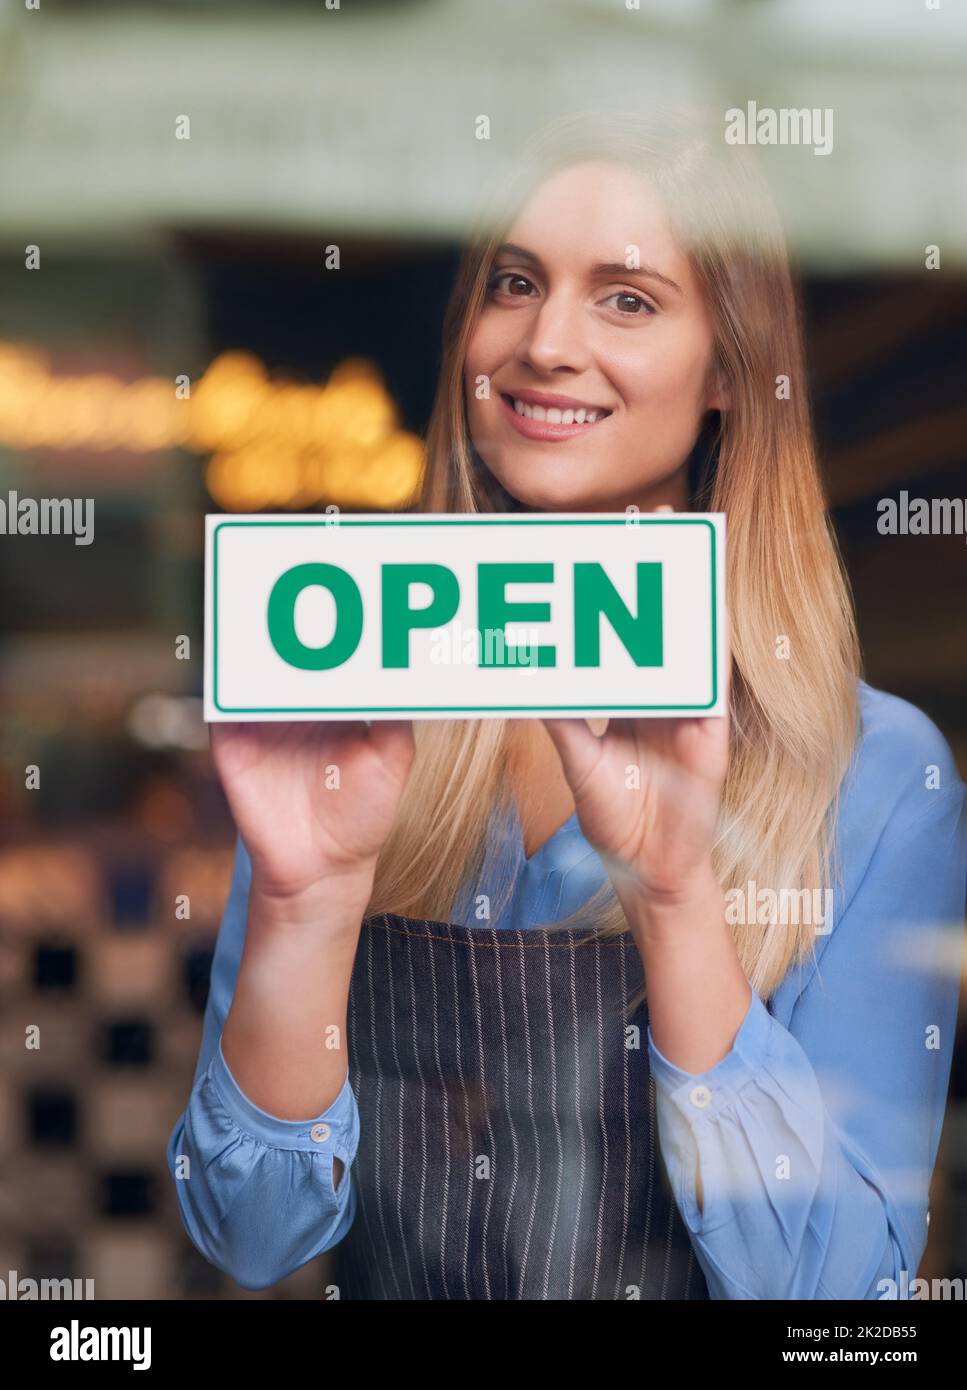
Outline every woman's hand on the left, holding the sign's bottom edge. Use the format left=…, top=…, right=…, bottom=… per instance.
left=210, top=720, right=415, bottom=901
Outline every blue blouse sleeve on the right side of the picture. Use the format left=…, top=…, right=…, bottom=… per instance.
left=649, top=702, right=967, bottom=1300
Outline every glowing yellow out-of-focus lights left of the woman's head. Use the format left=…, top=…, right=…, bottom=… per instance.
left=0, top=342, right=424, bottom=512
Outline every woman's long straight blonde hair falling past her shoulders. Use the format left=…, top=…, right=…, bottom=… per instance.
left=367, top=110, right=860, bottom=999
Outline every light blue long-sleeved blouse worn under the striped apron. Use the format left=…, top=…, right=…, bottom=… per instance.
left=167, top=682, right=967, bottom=1298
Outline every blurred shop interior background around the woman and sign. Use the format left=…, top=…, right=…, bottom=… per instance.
left=0, top=0, right=967, bottom=1298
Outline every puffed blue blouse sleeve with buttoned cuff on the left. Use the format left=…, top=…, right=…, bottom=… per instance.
left=167, top=837, right=358, bottom=1289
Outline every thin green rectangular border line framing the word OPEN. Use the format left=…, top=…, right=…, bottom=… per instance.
left=211, top=516, right=718, bottom=714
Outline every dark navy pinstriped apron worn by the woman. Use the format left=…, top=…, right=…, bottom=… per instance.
left=333, top=913, right=709, bottom=1300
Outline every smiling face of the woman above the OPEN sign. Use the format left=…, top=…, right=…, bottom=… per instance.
left=464, top=163, right=724, bottom=512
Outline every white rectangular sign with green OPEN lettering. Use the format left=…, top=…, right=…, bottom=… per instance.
left=204, top=512, right=725, bottom=720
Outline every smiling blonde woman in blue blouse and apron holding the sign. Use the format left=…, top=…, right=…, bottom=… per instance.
left=168, top=115, right=967, bottom=1300
